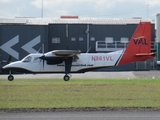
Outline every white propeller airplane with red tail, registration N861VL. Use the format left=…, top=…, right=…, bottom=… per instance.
left=3, top=22, right=155, bottom=81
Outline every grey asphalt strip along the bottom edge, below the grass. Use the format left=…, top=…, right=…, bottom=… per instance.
left=0, top=111, right=160, bottom=120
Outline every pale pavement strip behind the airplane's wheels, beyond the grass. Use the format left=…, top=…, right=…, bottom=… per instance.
left=0, top=70, right=160, bottom=79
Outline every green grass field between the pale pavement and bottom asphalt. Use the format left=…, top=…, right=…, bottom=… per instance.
left=0, top=78, right=160, bottom=109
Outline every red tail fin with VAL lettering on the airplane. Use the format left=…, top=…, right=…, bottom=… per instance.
left=118, top=22, right=155, bottom=65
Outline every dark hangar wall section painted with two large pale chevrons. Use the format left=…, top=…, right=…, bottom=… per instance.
left=0, top=25, right=48, bottom=61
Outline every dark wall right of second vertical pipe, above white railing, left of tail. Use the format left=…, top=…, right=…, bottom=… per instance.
left=89, top=24, right=137, bottom=52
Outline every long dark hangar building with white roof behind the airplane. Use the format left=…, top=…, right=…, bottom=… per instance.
left=0, top=16, right=155, bottom=71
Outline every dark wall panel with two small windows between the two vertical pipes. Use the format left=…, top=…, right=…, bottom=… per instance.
left=68, top=24, right=87, bottom=52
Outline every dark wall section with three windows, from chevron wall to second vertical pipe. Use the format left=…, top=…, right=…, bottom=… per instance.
left=48, top=24, right=87, bottom=52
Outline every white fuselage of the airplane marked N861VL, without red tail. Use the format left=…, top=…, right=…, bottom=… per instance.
left=3, top=50, right=124, bottom=73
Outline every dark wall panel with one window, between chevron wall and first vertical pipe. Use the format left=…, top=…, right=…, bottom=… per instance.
left=48, top=24, right=68, bottom=51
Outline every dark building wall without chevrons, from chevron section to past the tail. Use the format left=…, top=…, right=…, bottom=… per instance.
left=48, top=24, right=155, bottom=53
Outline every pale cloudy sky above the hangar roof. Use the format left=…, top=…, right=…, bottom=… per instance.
left=0, top=0, right=160, bottom=21
